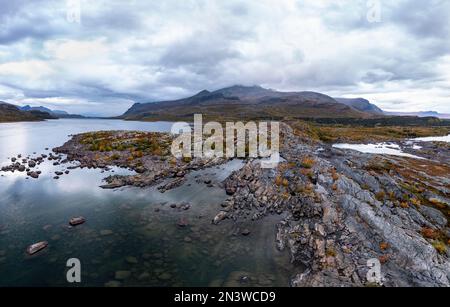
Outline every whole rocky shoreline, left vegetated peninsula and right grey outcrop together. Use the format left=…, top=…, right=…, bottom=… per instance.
left=2, top=125, right=450, bottom=287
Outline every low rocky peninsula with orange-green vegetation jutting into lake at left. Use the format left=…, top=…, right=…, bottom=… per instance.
left=54, top=131, right=227, bottom=191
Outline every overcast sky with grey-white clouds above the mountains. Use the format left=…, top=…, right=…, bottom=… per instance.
left=0, top=0, right=450, bottom=116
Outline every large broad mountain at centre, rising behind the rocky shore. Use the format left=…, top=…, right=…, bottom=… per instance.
left=119, top=85, right=373, bottom=121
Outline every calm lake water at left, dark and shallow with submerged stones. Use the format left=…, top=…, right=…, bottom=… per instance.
left=0, top=120, right=296, bottom=286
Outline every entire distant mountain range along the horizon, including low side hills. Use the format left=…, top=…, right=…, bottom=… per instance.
left=0, top=85, right=450, bottom=122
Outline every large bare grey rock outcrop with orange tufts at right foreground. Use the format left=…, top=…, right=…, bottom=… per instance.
left=215, top=127, right=450, bottom=287
